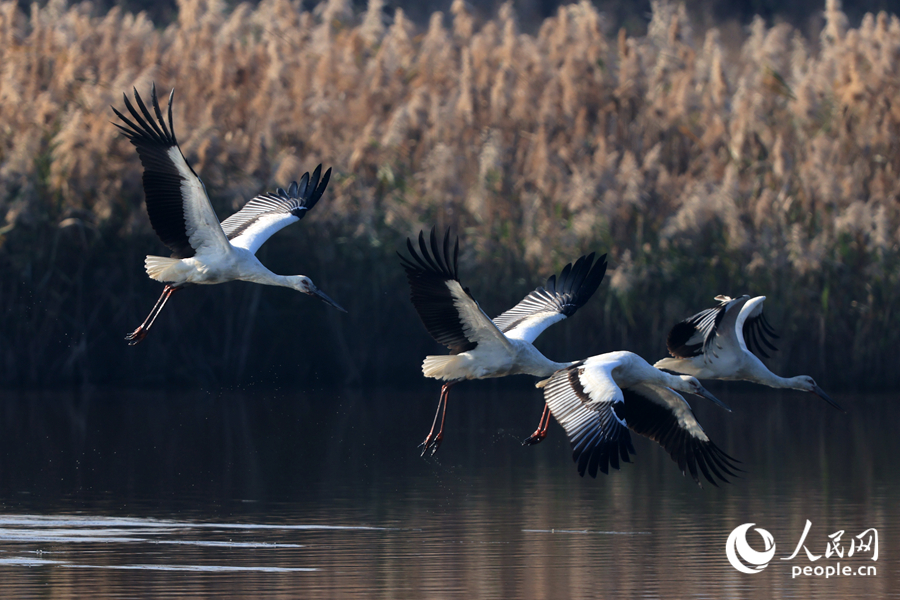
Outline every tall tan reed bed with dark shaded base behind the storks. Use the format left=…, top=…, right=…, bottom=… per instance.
left=0, top=0, right=900, bottom=390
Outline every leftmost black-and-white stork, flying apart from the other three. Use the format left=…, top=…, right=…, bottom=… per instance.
left=113, top=84, right=346, bottom=345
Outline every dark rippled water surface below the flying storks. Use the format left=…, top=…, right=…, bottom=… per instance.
left=0, top=380, right=900, bottom=598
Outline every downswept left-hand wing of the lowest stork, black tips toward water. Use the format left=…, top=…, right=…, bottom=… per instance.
left=544, top=363, right=634, bottom=477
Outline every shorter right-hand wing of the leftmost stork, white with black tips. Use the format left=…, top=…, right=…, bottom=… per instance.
left=222, top=165, right=331, bottom=254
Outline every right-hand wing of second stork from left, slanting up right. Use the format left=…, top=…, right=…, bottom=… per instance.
left=494, top=252, right=606, bottom=342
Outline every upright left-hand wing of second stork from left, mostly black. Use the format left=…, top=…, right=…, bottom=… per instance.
left=400, top=229, right=513, bottom=354
